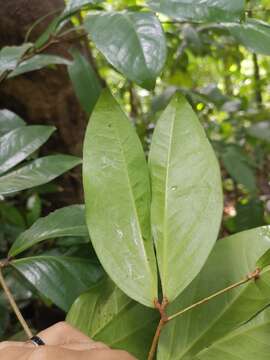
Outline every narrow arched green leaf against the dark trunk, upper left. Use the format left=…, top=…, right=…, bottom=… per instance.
left=8, top=55, right=71, bottom=78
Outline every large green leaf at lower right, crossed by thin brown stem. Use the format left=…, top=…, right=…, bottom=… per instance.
left=158, top=226, right=270, bottom=360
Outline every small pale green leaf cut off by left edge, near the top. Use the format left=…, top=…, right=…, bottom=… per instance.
left=0, top=43, right=32, bottom=76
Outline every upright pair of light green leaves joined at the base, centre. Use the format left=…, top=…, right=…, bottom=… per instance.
left=83, top=91, right=222, bottom=307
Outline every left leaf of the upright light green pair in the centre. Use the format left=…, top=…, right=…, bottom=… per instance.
left=83, top=91, right=157, bottom=306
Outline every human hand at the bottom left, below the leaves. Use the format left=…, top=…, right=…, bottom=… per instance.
left=0, top=322, right=136, bottom=360
